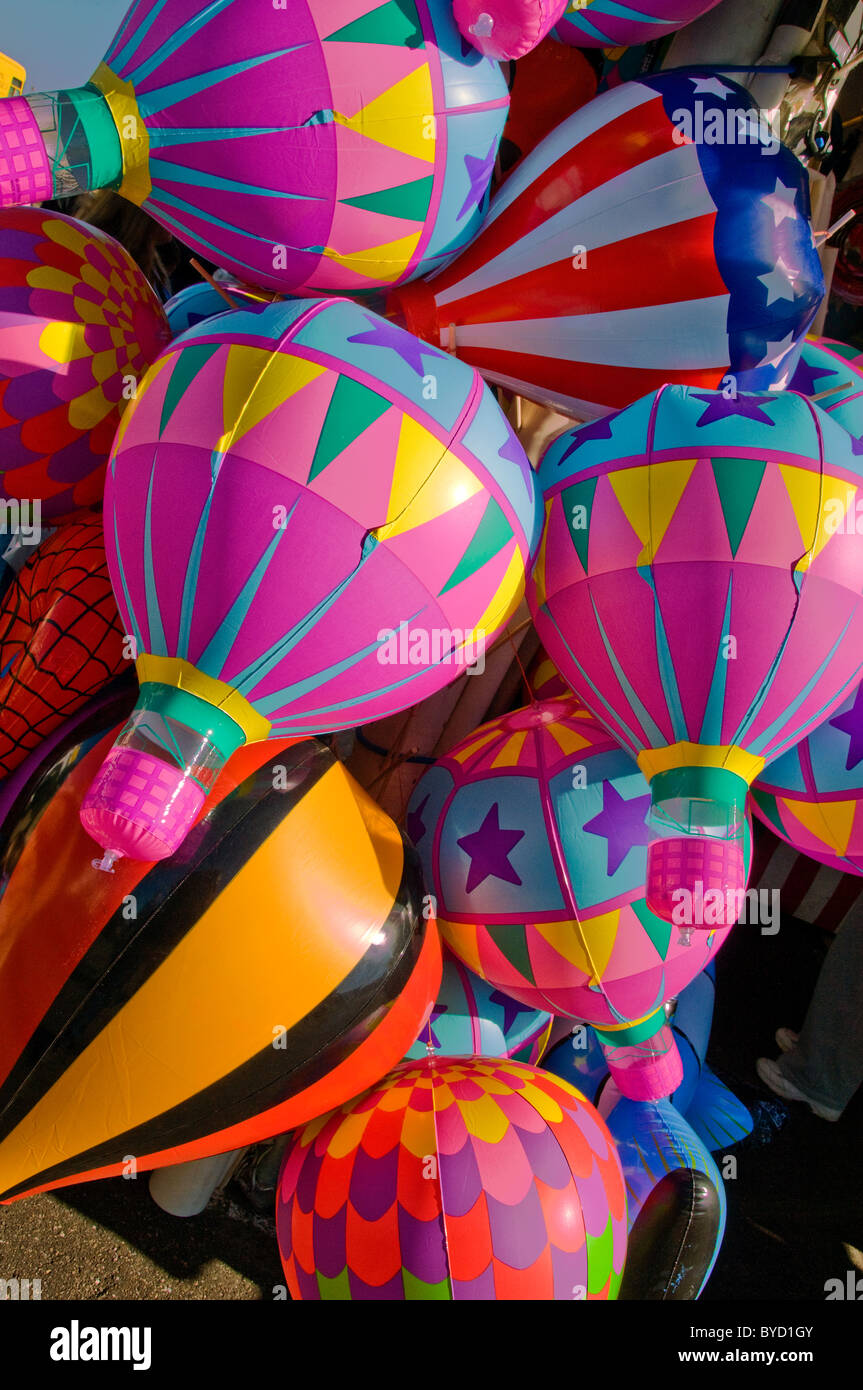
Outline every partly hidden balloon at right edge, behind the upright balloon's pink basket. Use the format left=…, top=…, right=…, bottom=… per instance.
left=752, top=685, right=863, bottom=874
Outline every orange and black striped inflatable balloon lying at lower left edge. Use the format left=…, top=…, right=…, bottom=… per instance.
left=0, top=726, right=441, bottom=1201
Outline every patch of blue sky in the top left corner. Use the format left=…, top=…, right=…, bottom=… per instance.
left=0, top=0, right=129, bottom=92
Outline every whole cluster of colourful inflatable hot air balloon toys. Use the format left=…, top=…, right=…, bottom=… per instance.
left=0, top=0, right=863, bottom=1301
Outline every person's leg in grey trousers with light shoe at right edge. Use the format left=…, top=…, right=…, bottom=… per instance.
left=775, top=913, right=863, bottom=1111
